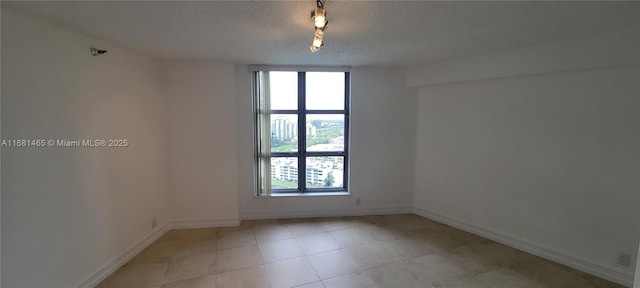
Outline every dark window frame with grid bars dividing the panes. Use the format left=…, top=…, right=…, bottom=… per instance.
left=252, top=69, right=351, bottom=195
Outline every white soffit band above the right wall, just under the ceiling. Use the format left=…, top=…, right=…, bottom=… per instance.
left=407, top=28, right=640, bottom=86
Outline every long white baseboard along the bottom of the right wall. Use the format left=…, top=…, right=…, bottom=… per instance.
left=414, top=208, right=634, bottom=287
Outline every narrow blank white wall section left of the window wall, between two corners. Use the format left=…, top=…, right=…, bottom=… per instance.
left=161, top=61, right=240, bottom=227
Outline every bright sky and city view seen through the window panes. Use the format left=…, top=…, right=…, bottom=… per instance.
left=270, top=72, right=348, bottom=192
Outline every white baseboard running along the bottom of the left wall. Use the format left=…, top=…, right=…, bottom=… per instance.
left=74, top=223, right=171, bottom=288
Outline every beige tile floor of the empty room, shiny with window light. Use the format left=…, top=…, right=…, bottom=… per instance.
left=97, top=215, right=622, bottom=288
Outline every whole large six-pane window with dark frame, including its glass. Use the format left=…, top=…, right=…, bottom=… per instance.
left=253, top=71, right=350, bottom=195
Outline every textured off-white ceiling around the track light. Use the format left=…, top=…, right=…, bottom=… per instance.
left=2, top=0, right=640, bottom=66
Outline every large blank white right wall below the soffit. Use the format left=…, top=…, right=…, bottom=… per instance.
left=408, top=34, right=640, bottom=285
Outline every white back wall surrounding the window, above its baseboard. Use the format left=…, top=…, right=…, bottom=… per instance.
left=236, top=66, right=416, bottom=219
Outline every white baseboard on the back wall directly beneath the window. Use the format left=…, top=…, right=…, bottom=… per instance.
left=241, top=206, right=413, bottom=220
